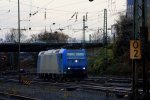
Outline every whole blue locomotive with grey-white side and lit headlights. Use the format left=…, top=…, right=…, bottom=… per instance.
left=37, top=49, right=87, bottom=79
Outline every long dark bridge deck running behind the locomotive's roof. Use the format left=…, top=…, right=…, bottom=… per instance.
left=0, top=43, right=102, bottom=52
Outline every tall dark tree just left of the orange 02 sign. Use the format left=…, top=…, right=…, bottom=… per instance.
left=114, top=15, right=133, bottom=56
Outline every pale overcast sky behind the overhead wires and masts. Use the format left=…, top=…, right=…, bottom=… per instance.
left=0, top=0, right=126, bottom=39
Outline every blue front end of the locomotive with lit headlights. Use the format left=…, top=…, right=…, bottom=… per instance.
left=66, top=49, right=87, bottom=77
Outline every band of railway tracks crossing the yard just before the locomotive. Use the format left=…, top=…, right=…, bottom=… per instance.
left=1, top=74, right=137, bottom=97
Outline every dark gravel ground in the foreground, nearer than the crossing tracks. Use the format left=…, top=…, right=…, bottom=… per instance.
left=0, top=82, right=127, bottom=100
